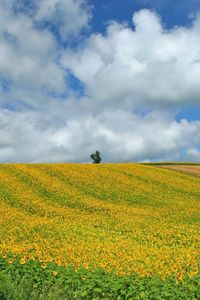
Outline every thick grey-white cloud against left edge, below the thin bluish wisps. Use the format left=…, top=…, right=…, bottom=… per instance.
left=0, top=0, right=66, bottom=101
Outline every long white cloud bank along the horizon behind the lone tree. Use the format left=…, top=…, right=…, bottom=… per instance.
left=0, top=110, right=200, bottom=162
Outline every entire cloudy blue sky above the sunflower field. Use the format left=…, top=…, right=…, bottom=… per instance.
left=0, top=0, right=200, bottom=163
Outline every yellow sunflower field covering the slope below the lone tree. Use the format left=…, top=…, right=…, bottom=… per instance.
left=0, top=163, right=200, bottom=299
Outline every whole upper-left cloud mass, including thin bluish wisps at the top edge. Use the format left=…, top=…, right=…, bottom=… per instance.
left=0, top=0, right=90, bottom=105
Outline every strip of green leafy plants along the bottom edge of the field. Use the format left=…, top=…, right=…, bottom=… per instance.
left=0, top=260, right=200, bottom=300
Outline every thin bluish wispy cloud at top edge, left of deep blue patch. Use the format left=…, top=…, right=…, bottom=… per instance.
left=7, top=0, right=92, bottom=40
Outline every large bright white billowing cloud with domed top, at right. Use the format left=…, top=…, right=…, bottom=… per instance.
left=62, top=10, right=200, bottom=107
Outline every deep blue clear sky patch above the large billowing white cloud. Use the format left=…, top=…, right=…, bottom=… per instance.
left=90, top=0, right=200, bottom=32
